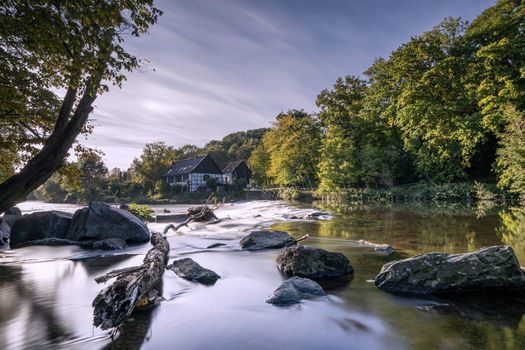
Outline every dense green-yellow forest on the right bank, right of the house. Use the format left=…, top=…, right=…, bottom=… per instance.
left=250, top=0, right=525, bottom=201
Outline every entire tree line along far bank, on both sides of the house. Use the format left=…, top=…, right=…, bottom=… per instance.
left=4, top=0, right=525, bottom=202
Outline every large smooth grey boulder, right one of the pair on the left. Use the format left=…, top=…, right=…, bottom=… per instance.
left=67, top=202, right=149, bottom=242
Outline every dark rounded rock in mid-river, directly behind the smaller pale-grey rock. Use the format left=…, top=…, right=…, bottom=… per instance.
left=276, top=245, right=354, bottom=280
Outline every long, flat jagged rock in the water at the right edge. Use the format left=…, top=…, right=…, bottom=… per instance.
left=375, top=246, right=525, bottom=295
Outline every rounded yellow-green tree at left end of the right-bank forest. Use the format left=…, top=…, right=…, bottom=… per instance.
left=263, top=110, right=320, bottom=187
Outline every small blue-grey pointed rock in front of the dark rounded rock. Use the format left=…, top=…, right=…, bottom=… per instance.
left=266, top=277, right=326, bottom=305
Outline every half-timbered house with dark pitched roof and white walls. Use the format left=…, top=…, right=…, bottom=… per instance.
left=161, top=154, right=224, bottom=192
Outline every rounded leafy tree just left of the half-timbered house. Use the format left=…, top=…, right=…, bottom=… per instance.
left=129, top=142, right=177, bottom=194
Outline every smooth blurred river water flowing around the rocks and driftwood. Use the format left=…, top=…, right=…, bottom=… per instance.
left=0, top=201, right=525, bottom=350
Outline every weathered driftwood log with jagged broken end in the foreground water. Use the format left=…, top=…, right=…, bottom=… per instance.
left=92, top=232, right=170, bottom=329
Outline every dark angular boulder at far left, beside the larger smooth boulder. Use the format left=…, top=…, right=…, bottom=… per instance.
left=10, top=210, right=73, bottom=248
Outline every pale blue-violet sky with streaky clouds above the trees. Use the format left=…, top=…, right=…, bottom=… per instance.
left=84, top=0, right=495, bottom=169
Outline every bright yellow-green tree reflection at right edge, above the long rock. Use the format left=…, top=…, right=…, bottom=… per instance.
left=496, top=207, right=525, bottom=249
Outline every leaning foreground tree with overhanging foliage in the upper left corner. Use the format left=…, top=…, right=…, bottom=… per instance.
left=0, top=0, right=161, bottom=212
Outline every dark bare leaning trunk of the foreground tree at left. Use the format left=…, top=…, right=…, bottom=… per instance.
left=0, top=77, right=100, bottom=213
